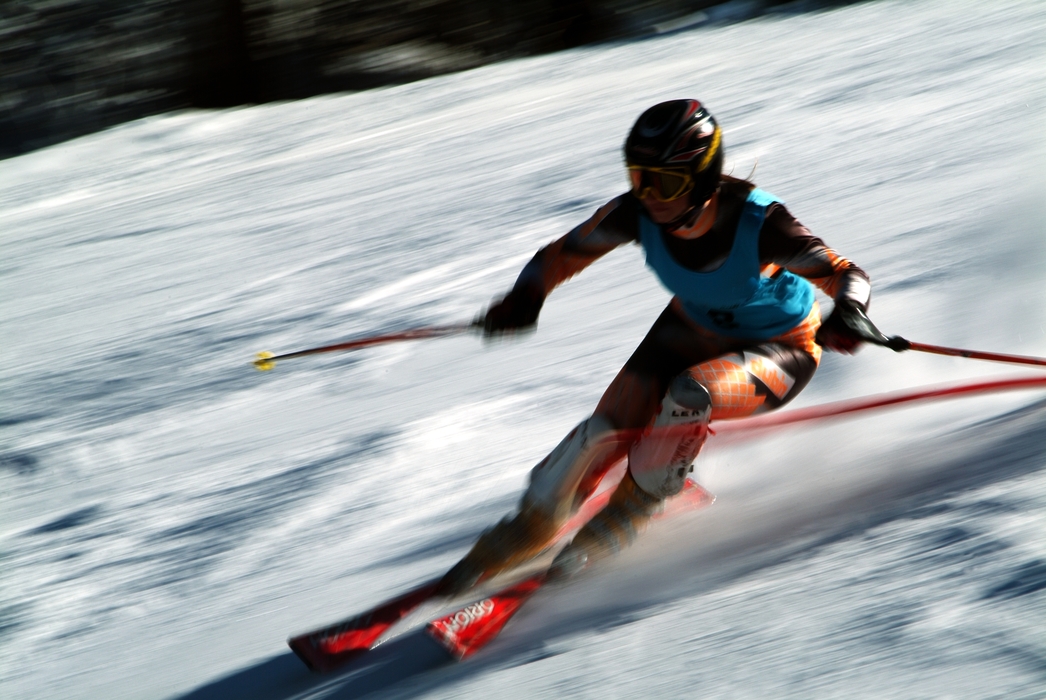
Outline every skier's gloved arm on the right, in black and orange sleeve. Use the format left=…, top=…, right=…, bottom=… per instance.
left=759, top=204, right=887, bottom=353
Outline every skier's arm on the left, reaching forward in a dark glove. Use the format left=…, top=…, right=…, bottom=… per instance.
left=483, top=195, right=637, bottom=335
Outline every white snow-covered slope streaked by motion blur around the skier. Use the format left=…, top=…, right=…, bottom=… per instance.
left=0, top=0, right=1046, bottom=699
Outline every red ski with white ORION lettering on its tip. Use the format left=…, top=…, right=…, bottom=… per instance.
left=425, top=479, right=715, bottom=660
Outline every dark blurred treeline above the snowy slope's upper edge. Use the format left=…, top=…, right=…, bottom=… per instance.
left=0, top=0, right=861, bottom=157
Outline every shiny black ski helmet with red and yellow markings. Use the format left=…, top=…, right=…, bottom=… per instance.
left=624, top=99, right=723, bottom=206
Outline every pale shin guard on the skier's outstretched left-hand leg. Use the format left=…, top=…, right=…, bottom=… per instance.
left=520, top=415, right=615, bottom=520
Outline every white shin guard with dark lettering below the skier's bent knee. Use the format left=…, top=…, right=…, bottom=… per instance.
left=629, top=371, right=712, bottom=498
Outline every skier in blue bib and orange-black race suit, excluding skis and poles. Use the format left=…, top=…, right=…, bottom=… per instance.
left=439, top=99, right=886, bottom=594
